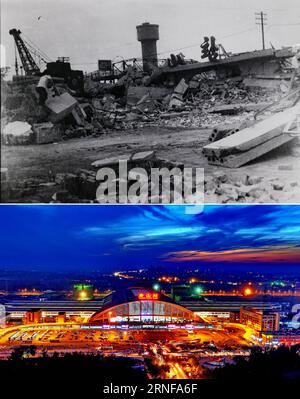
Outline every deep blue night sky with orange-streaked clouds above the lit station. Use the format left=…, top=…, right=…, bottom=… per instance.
left=0, top=205, right=300, bottom=271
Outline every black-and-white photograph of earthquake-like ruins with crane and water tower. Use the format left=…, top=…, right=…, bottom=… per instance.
left=1, top=0, right=300, bottom=204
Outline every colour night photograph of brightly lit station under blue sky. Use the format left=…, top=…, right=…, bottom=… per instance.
left=0, top=205, right=300, bottom=390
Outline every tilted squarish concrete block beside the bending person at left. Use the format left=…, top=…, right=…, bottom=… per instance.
left=45, top=93, right=78, bottom=123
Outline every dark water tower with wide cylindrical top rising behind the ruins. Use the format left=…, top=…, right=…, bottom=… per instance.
left=136, top=22, right=159, bottom=72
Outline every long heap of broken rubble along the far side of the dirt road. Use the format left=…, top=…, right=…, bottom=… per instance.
left=2, top=67, right=276, bottom=145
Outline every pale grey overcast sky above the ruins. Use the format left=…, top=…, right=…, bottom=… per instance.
left=1, top=0, right=300, bottom=71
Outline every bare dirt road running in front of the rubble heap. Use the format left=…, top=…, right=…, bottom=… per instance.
left=1, top=127, right=300, bottom=203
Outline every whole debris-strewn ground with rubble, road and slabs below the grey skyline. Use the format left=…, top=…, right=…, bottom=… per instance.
left=1, top=46, right=300, bottom=203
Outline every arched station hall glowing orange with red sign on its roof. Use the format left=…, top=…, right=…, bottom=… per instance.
left=89, top=288, right=196, bottom=324
